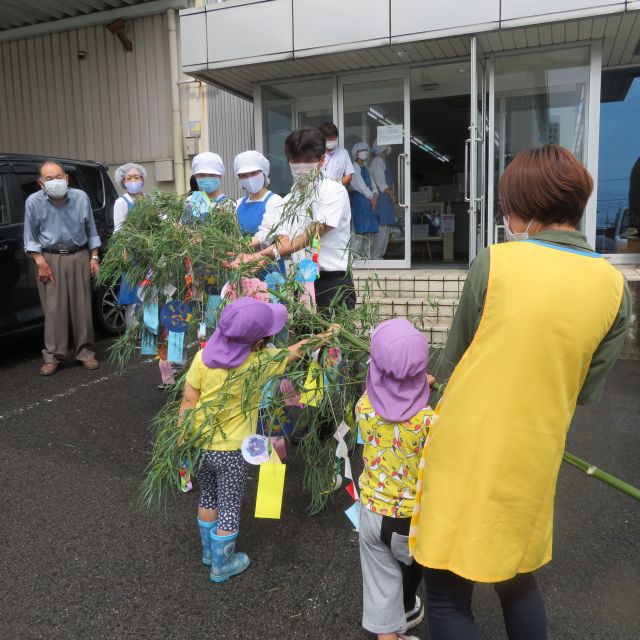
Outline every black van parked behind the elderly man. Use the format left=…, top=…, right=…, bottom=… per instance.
left=0, top=154, right=124, bottom=338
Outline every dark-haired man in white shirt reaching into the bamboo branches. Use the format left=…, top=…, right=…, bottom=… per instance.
left=236, top=128, right=356, bottom=310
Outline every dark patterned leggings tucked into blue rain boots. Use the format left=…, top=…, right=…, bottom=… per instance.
left=195, top=449, right=247, bottom=531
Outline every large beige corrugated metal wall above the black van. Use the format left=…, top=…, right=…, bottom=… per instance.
left=0, top=14, right=172, bottom=182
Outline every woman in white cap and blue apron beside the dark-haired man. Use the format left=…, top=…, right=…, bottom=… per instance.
left=233, top=151, right=282, bottom=268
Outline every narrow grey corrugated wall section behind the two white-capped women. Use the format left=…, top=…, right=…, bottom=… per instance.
left=207, top=86, right=255, bottom=198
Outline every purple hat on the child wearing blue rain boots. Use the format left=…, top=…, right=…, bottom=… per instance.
left=202, top=298, right=288, bottom=369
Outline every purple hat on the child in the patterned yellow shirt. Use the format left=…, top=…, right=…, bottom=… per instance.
left=367, top=318, right=429, bottom=422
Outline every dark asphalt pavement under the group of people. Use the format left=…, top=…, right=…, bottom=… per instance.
left=0, top=335, right=640, bottom=640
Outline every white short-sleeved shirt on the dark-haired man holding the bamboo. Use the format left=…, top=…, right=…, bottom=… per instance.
left=278, top=177, right=351, bottom=271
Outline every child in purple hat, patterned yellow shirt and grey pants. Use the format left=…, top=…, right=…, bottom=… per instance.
left=356, top=318, right=433, bottom=640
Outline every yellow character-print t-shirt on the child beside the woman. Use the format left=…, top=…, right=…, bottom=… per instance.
left=356, top=393, right=433, bottom=518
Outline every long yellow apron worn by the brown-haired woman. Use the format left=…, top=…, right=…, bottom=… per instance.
left=410, top=241, right=624, bottom=582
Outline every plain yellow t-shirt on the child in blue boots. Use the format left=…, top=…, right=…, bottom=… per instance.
left=187, top=349, right=289, bottom=451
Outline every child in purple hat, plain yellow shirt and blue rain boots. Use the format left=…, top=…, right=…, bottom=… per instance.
left=175, top=298, right=338, bottom=582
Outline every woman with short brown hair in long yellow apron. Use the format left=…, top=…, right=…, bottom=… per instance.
left=410, top=145, right=630, bottom=640
